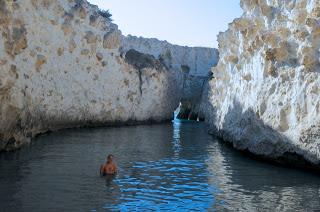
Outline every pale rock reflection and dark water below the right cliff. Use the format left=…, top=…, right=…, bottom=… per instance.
left=206, top=142, right=320, bottom=211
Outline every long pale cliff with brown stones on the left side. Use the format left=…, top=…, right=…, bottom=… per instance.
left=0, top=0, right=218, bottom=151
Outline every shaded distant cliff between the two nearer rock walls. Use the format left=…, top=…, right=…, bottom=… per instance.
left=121, top=35, right=219, bottom=119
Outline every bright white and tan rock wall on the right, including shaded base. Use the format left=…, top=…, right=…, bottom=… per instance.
left=203, top=0, right=320, bottom=167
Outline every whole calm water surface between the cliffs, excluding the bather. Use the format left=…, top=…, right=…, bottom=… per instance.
left=0, top=121, right=320, bottom=211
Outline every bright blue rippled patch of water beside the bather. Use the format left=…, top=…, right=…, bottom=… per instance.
left=104, top=158, right=214, bottom=210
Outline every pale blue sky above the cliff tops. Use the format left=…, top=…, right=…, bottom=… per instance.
left=89, top=0, right=242, bottom=47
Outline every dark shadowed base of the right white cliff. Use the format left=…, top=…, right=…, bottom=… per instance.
left=206, top=100, right=320, bottom=174
